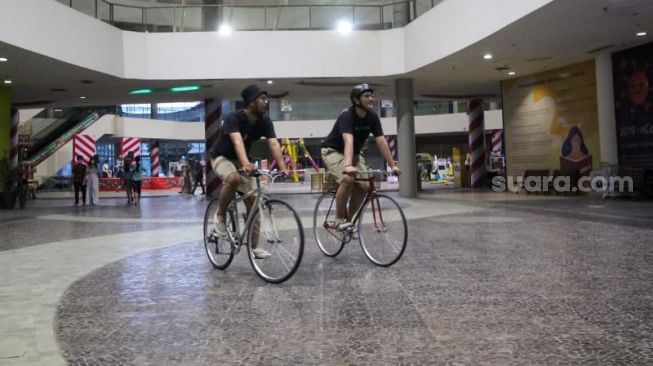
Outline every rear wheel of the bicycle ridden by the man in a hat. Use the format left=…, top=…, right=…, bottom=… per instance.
left=204, top=198, right=236, bottom=269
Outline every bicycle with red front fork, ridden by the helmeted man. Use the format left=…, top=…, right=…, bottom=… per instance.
left=313, top=170, right=408, bottom=267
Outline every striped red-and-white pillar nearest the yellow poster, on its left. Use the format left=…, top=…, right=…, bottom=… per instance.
left=467, top=99, right=485, bottom=188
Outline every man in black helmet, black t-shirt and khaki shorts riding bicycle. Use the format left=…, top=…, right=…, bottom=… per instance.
left=321, top=84, right=401, bottom=231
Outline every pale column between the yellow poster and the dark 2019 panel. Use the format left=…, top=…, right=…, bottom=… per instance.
left=596, top=52, right=619, bottom=165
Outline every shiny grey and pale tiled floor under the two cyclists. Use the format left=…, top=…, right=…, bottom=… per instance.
left=0, top=190, right=653, bottom=365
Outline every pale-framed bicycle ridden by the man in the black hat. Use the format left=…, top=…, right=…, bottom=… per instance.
left=204, top=172, right=304, bottom=283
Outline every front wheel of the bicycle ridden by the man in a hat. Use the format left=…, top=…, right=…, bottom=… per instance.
left=247, top=200, right=304, bottom=283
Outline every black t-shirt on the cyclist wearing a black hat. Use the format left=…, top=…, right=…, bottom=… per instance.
left=211, top=110, right=277, bottom=159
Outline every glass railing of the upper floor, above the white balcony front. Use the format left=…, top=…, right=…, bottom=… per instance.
left=56, top=0, right=443, bottom=32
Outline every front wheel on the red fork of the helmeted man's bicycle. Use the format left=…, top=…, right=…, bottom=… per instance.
left=358, top=194, right=408, bottom=267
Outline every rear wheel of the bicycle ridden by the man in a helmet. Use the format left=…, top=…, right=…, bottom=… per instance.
left=313, top=192, right=345, bottom=257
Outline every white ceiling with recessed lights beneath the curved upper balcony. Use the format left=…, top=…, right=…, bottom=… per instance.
left=0, top=0, right=653, bottom=107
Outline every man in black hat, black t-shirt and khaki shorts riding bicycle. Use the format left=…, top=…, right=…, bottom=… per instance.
left=207, top=85, right=288, bottom=259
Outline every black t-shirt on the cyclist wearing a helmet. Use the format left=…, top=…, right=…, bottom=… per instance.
left=322, top=106, right=383, bottom=154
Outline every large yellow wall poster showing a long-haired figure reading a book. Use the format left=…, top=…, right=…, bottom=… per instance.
left=501, top=61, right=601, bottom=177
